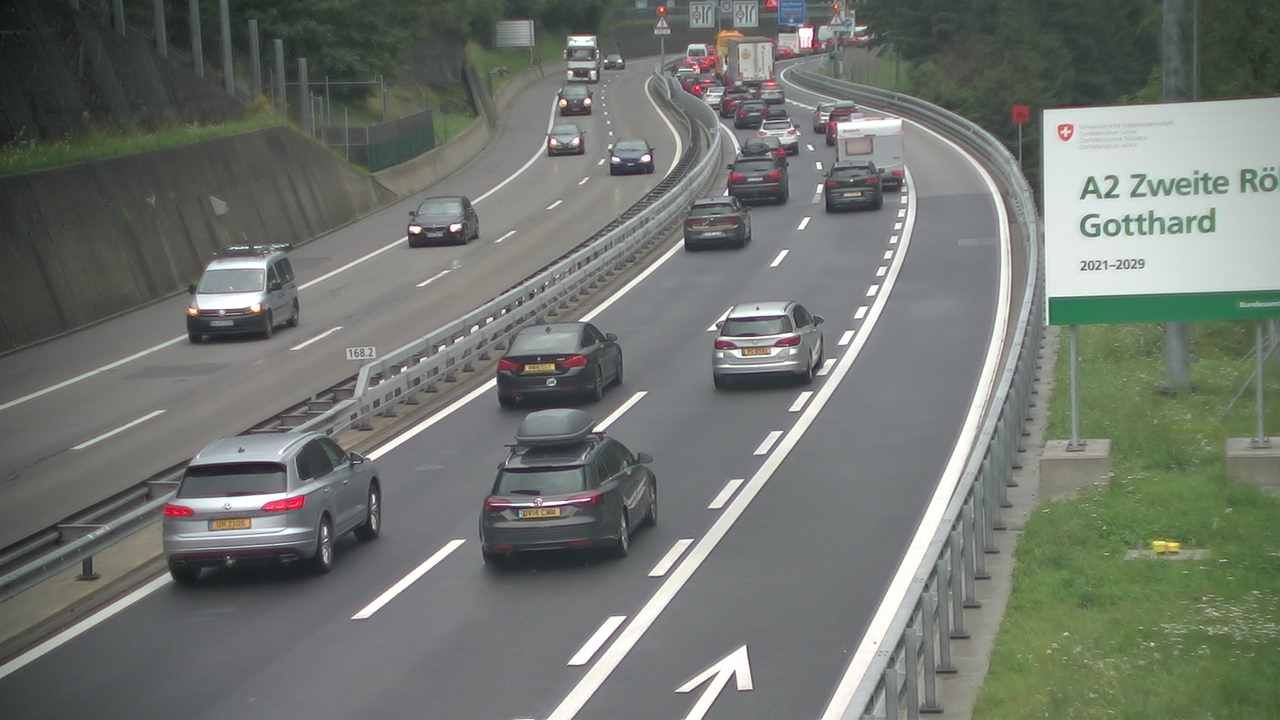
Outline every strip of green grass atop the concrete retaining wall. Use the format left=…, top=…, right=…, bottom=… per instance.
left=0, top=111, right=283, bottom=176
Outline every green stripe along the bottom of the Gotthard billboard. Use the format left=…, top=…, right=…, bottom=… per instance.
left=1048, top=290, right=1280, bottom=325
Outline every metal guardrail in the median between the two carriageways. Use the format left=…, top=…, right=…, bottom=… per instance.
left=0, top=73, right=722, bottom=602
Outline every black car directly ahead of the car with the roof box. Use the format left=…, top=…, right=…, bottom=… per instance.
left=498, top=317, right=622, bottom=407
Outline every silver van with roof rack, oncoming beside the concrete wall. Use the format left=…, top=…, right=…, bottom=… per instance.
left=187, top=245, right=302, bottom=343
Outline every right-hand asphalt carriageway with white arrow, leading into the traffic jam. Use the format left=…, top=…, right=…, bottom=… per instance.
left=0, top=61, right=1000, bottom=720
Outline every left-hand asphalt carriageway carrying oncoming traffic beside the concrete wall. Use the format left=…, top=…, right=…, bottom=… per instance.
left=0, top=63, right=680, bottom=547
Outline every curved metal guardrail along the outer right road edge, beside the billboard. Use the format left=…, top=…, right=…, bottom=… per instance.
left=786, top=68, right=1044, bottom=720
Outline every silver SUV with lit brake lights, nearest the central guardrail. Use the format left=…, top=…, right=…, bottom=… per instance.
left=164, top=433, right=381, bottom=584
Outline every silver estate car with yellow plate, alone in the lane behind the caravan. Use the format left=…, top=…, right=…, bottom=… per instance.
left=712, top=301, right=824, bottom=387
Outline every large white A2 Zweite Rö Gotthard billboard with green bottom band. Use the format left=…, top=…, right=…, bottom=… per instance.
left=1043, top=97, right=1280, bottom=325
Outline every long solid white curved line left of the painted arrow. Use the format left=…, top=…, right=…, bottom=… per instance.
left=545, top=165, right=915, bottom=720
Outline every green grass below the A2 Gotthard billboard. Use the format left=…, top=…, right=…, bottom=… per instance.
left=974, top=323, right=1280, bottom=720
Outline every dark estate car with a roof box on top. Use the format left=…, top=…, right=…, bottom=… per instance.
left=480, top=409, right=658, bottom=565
